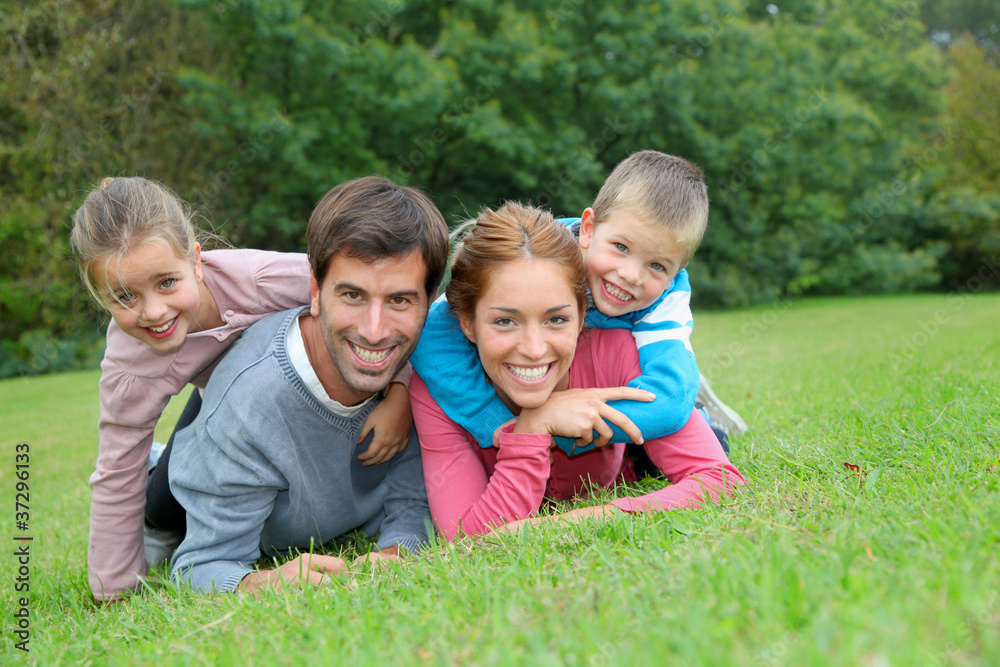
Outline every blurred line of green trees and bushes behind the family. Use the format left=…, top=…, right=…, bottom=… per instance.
left=0, top=0, right=1000, bottom=376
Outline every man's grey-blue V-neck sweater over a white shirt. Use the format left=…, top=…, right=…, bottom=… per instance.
left=170, top=309, right=430, bottom=592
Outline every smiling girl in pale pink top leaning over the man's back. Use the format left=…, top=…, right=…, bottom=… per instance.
left=70, top=178, right=412, bottom=601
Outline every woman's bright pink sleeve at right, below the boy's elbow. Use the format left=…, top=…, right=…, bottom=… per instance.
left=614, top=410, right=746, bottom=513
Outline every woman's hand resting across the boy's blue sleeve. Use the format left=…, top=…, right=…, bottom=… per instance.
left=514, top=387, right=656, bottom=447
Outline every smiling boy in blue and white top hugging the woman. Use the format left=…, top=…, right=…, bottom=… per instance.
left=410, top=150, right=746, bottom=454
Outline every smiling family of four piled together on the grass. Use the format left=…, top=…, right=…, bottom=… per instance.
left=71, top=151, right=745, bottom=601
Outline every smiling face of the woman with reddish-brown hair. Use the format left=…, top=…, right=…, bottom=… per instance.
left=460, top=259, right=583, bottom=412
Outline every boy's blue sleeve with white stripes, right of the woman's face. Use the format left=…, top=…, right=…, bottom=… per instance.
left=556, top=269, right=700, bottom=452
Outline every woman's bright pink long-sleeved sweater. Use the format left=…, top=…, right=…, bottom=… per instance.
left=410, top=329, right=744, bottom=540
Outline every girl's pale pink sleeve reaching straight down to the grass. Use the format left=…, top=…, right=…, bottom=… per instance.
left=87, top=354, right=176, bottom=600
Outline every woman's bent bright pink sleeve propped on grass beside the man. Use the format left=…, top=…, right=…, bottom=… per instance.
left=410, top=374, right=551, bottom=540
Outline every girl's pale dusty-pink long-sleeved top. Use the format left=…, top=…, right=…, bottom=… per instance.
left=87, top=250, right=309, bottom=600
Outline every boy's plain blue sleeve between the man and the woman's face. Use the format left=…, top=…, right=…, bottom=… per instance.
left=410, top=296, right=514, bottom=447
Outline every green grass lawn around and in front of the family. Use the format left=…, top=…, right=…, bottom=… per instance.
left=0, top=295, right=1000, bottom=667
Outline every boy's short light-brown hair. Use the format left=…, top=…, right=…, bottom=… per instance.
left=594, top=150, right=708, bottom=259
